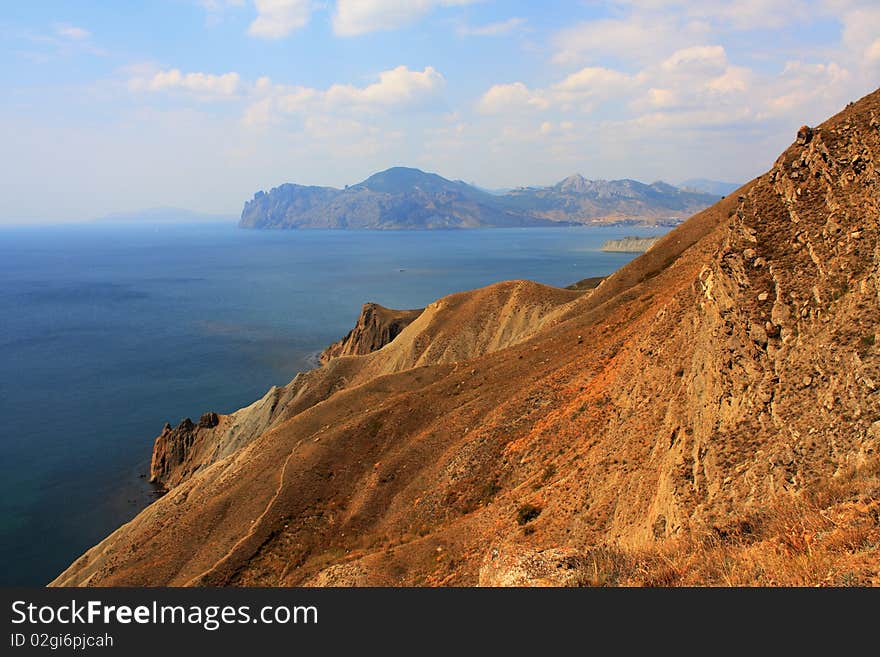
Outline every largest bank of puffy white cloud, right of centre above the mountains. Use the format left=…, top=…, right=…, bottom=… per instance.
left=477, top=38, right=836, bottom=136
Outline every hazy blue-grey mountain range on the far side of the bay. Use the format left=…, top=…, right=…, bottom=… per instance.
left=239, top=167, right=720, bottom=229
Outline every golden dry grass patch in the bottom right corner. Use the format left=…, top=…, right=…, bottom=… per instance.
left=579, top=459, right=880, bottom=586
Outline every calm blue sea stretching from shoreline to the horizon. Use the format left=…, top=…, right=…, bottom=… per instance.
left=0, top=224, right=658, bottom=585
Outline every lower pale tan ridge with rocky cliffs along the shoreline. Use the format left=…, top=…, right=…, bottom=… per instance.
left=144, top=281, right=577, bottom=490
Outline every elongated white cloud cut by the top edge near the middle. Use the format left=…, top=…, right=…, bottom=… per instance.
left=333, top=0, right=479, bottom=36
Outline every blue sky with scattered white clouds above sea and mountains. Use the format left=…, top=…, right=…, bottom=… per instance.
left=0, top=0, right=880, bottom=224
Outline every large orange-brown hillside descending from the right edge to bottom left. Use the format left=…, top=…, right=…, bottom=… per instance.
left=54, top=87, right=880, bottom=585
